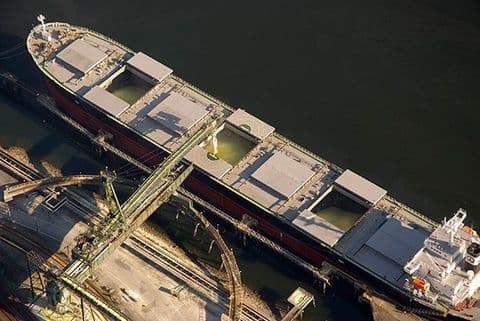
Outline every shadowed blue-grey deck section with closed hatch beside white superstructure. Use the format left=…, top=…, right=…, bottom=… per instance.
left=335, top=197, right=436, bottom=288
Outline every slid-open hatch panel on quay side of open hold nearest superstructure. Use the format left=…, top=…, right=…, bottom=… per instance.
left=292, top=210, right=345, bottom=246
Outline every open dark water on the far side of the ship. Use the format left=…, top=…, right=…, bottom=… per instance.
left=0, top=0, right=480, bottom=320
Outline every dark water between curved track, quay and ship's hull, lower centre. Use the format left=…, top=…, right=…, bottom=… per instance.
left=149, top=206, right=371, bottom=321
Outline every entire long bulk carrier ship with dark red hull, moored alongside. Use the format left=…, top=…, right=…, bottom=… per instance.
left=27, top=16, right=480, bottom=320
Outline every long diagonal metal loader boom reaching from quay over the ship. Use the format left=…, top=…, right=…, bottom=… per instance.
left=66, top=110, right=222, bottom=282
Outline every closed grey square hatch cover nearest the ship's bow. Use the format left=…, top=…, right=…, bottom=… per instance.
left=56, top=38, right=107, bottom=74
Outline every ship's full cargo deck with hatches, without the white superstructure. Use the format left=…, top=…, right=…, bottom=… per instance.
left=27, top=23, right=478, bottom=313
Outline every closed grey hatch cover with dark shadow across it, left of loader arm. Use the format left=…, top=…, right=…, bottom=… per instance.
left=147, top=92, right=208, bottom=136
